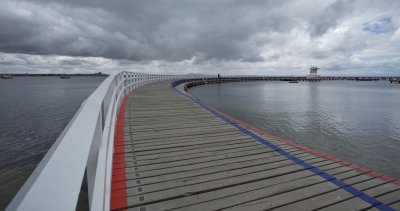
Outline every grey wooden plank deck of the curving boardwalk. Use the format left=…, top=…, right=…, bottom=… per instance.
left=112, top=82, right=400, bottom=211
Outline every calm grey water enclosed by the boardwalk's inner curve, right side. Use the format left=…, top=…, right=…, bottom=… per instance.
left=190, top=81, right=400, bottom=179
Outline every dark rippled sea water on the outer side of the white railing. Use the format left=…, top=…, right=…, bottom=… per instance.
left=0, top=76, right=105, bottom=210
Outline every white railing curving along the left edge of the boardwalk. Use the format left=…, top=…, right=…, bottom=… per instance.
left=6, top=72, right=215, bottom=210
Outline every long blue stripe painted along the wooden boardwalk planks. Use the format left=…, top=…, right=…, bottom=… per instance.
left=171, top=81, right=395, bottom=211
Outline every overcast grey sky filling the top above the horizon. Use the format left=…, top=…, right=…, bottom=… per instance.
left=0, top=0, right=400, bottom=75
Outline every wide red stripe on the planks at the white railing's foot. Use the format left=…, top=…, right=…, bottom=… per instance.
left=110, top=92, right=133, bottom=210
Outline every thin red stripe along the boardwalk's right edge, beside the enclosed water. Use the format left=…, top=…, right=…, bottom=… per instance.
left=202, top=106, right=400, bottom=185
